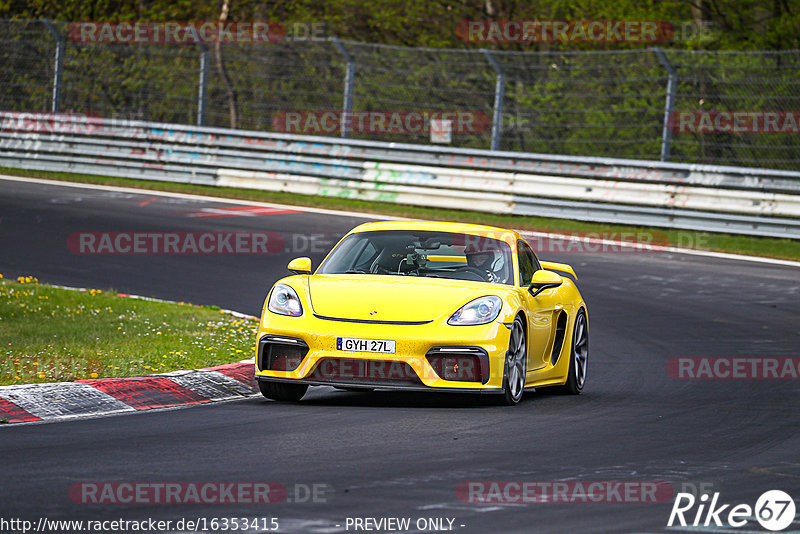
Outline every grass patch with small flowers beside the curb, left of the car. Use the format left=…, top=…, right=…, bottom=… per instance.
left=0, top=277, right=258, bottom=385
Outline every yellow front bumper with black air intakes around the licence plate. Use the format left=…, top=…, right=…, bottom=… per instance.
left=256, top=312, right=510, bottom=393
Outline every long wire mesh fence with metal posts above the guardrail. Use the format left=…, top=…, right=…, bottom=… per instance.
left=0, top=20, right=800, bottom=169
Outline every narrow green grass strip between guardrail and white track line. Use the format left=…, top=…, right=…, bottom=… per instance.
left=0, top=167, right=800, bottom=260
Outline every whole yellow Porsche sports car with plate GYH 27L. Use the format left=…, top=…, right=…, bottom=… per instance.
left=256, top=221, right=589, bottom=405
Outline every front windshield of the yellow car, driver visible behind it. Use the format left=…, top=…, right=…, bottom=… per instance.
left=317, top=230, right=514, bottom=284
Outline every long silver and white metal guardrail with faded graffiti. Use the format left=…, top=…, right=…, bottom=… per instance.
left=0, top=113, right=800, bottom=239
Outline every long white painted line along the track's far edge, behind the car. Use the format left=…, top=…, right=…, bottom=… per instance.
left=0, top=175, right=800, bottom=268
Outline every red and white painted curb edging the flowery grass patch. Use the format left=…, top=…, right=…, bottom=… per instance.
left=0, top=286, right=258, bottom=423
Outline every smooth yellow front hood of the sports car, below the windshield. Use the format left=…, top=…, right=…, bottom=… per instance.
left=308, top=274, right=490, bottom=322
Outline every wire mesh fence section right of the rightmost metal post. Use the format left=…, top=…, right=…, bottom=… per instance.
left=668, top=50, right=800, bottom=170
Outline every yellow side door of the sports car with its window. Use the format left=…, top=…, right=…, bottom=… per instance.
left=517, top=240, right=561, bottom=373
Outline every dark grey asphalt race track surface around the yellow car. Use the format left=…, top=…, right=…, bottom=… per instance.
left=0, top=180, right=800, bottom=533
